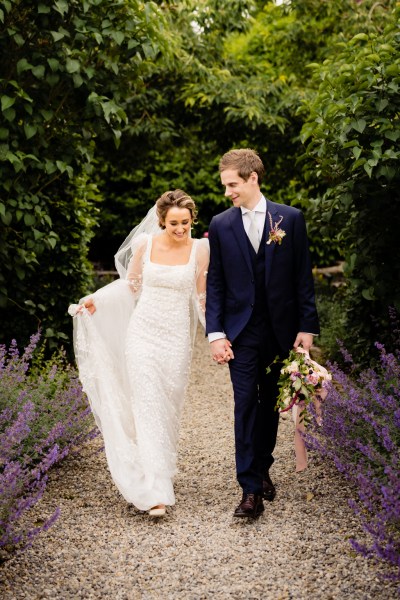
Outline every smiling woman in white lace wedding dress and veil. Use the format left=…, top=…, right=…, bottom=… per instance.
left=68, top=190, right=209, bottom=516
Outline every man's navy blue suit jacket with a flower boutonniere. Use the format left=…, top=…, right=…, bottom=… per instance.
left=206, top=200, right=319, bottom=352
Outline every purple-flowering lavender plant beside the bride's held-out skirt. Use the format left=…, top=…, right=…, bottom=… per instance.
left=0, top=333, right=97, bottom=549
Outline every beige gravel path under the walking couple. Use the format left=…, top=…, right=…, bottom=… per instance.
left=0, top=335, right=398, bottom=600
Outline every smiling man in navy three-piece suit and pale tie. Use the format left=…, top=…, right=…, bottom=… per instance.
left=206, top=149, right=319, bottom=518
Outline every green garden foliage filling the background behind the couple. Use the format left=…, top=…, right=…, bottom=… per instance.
left=0, top=0, right=400, bottom=580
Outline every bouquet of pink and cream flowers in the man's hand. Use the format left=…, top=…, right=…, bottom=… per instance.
left=276, top=348, right=332, bottom=420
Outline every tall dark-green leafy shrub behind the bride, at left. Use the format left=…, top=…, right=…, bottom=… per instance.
left=0, top=0, right=166, bottom=350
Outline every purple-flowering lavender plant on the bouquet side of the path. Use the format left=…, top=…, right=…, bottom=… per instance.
left=306, top=330, right=400, bottom=580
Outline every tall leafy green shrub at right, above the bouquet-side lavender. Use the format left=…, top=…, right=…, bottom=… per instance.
left=301, top=2, right=400, bottom=366
